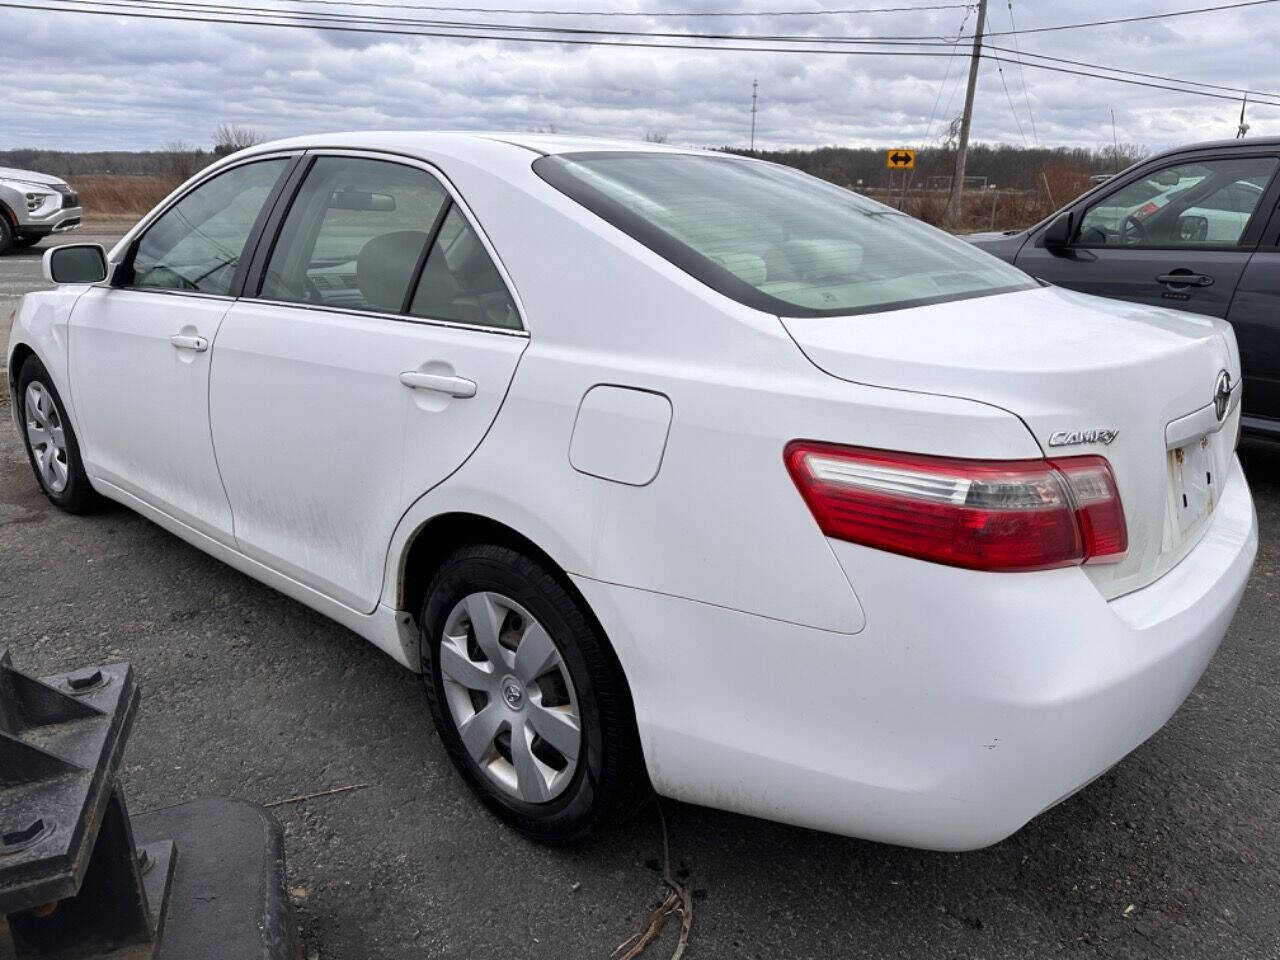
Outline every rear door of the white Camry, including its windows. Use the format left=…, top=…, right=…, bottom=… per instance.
left=210, top=151, right=527, bottom=612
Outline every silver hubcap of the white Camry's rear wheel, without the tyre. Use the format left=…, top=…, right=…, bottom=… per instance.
left=440, top=593, right=582, bottom=804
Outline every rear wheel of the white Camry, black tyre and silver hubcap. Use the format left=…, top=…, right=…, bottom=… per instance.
left=421, top=545, right=649, bottom=844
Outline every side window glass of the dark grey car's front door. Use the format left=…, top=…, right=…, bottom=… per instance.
left=1075, top=156, right=1277, bottom=247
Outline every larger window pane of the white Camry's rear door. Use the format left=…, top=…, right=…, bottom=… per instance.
left=261, top=156, right=448, bottom=314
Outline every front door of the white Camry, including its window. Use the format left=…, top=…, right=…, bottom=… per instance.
left=68, top=156, right=294, bottom=544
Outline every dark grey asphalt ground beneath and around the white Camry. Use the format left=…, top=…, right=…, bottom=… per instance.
left=0, top=280, right=1280, bottom=960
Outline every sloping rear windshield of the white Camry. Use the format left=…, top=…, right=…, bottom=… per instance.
left=534, top=152, right=1037, bottom=316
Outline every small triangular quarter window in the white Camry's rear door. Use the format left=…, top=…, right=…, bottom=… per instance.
left=408, top=206, right=520, bottom=330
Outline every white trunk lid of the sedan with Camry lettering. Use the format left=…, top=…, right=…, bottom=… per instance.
left=782, top=288, right=1240, bottom=598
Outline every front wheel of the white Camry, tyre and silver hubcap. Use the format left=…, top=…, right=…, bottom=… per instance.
left=14, top=357, right=101, bottom=513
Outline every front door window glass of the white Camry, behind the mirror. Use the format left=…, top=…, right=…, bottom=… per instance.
left=129, top=157, right=291, bottom=294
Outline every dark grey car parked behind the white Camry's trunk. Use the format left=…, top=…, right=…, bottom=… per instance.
left=968, top=137, right=1280, bottom=438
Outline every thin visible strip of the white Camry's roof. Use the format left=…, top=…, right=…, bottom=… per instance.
left=235, top=131, right=707, bottom=159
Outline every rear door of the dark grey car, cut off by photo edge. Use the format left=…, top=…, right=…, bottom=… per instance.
left=1226, top=200, right=1280, bottom=427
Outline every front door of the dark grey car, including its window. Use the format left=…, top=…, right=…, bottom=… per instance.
left=1015, top=155, right=1277, bottom=317
